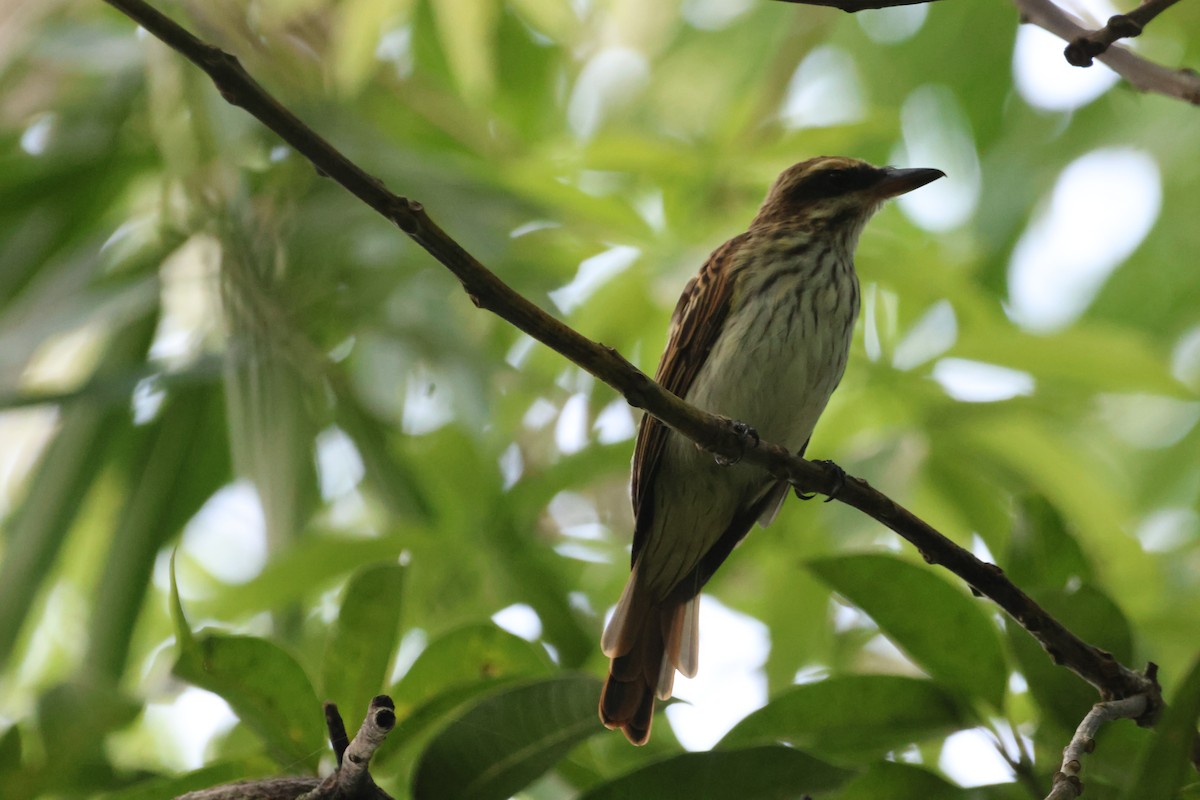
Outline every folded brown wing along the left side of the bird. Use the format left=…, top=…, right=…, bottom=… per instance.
left=632, top=234, right=748, bottom=561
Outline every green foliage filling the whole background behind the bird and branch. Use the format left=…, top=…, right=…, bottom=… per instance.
left=0, top=0, right=1200, bottom=800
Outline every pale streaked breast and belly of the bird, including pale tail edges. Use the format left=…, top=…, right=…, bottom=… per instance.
left=602, top=231, right=858, bottom=699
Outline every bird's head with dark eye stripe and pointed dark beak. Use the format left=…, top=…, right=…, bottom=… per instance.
left=751, top=156, right=946, bottom=237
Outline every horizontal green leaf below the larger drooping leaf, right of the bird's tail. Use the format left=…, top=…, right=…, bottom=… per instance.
left=719, top=675, right=967, bottom=760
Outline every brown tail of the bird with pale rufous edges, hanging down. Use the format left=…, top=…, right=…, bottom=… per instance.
left=600, top=565, right=700, bottom=745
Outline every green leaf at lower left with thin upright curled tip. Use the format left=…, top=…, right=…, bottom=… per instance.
left=170, top=569, right=325, bottom=770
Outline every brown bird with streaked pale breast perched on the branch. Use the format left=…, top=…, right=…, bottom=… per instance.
left=600, top=156, right=944, bottom=745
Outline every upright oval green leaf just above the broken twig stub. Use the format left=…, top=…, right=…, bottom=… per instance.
left=322, top=564, right=404, bottom=720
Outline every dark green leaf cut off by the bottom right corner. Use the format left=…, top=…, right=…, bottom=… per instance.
left=1122, top=658, right=1200, bottom=800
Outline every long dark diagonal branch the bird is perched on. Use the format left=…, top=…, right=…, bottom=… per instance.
left=104, top=0, right=1162, bottom=724
